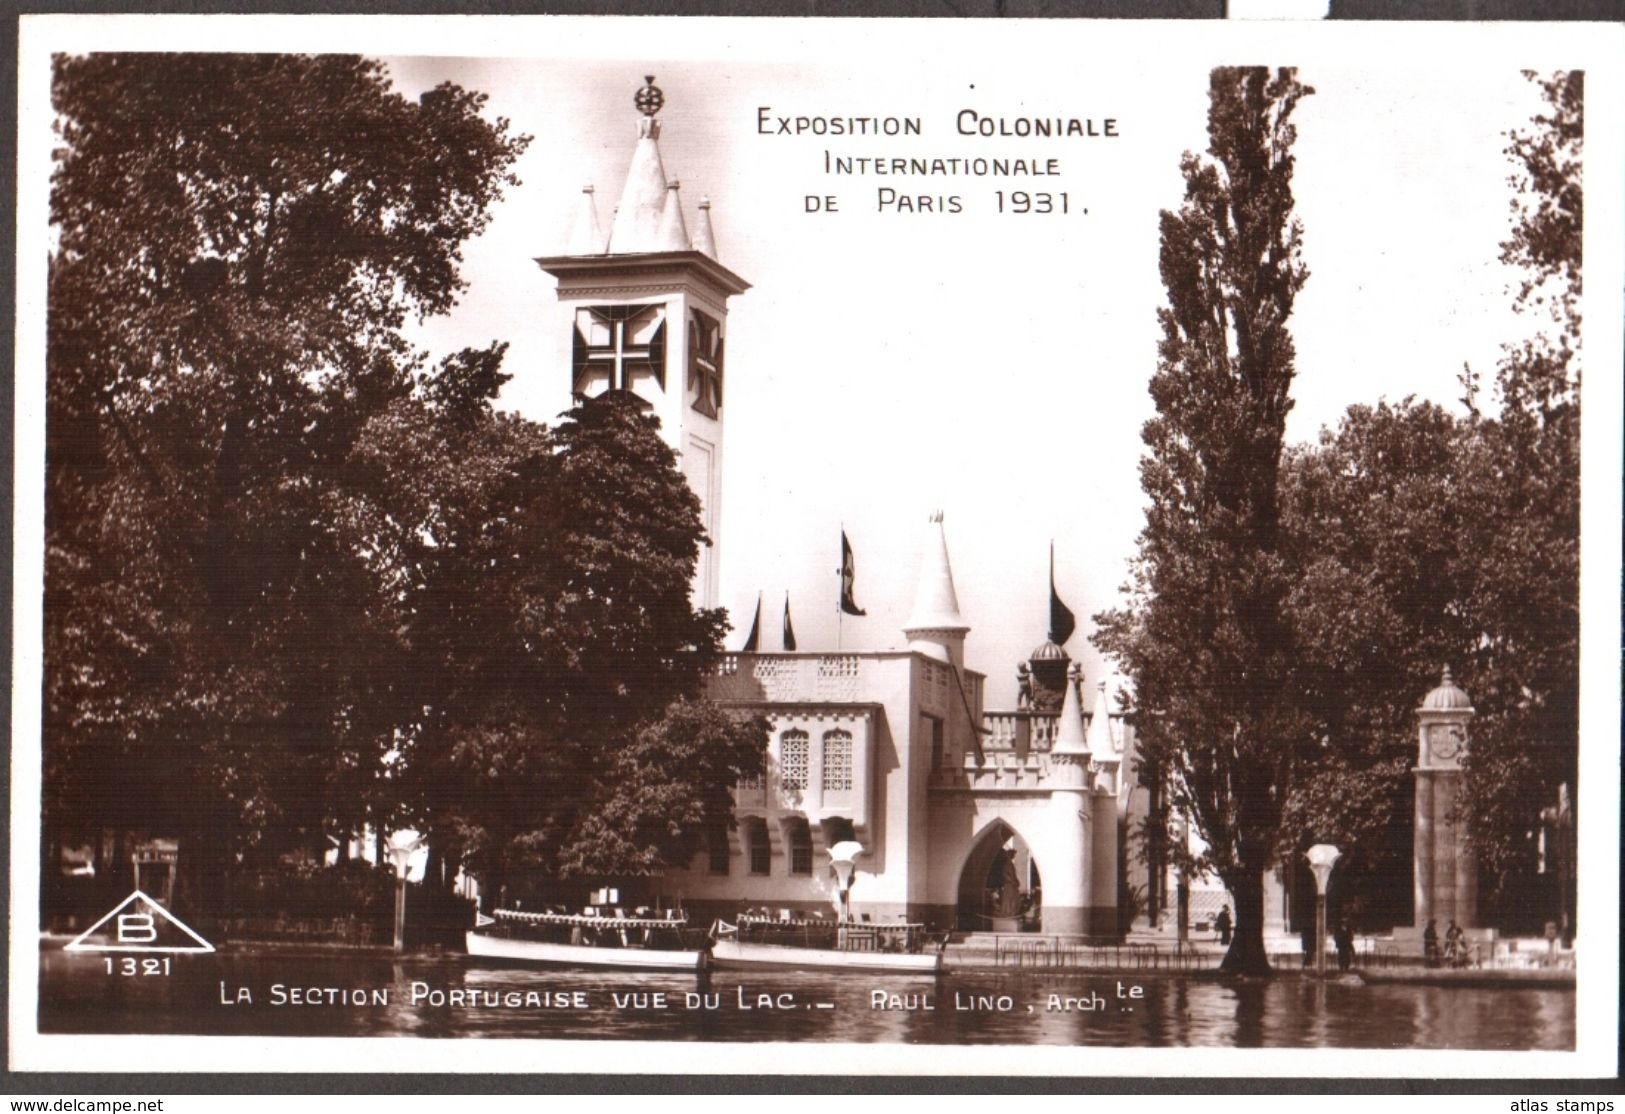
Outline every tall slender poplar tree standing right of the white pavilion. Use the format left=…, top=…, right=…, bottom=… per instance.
left=1097, top=68, right=1313, bottom=973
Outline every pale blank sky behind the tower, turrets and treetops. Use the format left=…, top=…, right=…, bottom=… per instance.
left=387, top=44, right=1541, bottom=706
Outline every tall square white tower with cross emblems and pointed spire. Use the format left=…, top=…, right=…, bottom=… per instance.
left=536, top=76, right=751, bottom=607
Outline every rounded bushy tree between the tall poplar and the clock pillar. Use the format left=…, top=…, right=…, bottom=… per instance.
left=1277, top=399, right=1472, bottom=926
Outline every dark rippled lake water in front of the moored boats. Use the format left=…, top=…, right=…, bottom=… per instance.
left=39, top=948, right=1575, bottom=1051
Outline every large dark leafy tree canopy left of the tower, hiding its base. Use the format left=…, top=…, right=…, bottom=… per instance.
left=46, top=55, right=765, bottom=922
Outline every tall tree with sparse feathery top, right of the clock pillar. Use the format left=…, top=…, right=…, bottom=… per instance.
left=1461, top=70, right=1584, bottom=916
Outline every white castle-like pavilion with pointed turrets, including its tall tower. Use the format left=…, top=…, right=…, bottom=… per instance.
left=538, top=78, right=1133, bottom=935
